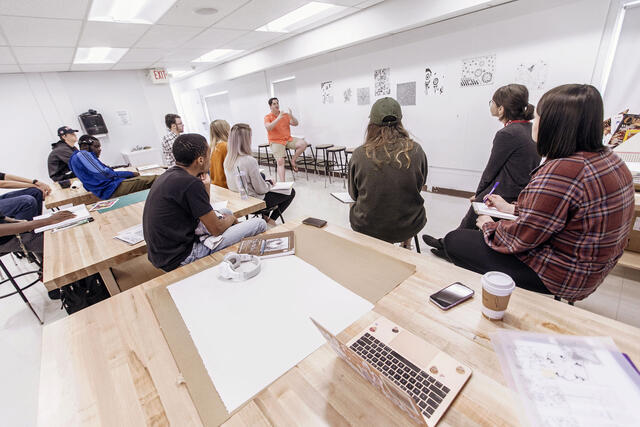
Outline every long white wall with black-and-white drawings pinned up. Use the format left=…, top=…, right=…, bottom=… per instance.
left=174, top=0, right=609, bottom=190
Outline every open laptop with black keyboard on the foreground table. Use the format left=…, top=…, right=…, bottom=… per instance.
left=311, top=316, right=471, bottom=426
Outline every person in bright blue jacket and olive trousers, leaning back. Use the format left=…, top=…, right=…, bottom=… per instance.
left=69, top=135, right=157, bottom=200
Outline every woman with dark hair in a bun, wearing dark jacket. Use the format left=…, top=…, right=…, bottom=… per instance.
left=422, top=84, right=540, bottom=258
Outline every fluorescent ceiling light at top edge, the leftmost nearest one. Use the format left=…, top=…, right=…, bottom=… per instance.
left=88, top=0, right=176, bottom=24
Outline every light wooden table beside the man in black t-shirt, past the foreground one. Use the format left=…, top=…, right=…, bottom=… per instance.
left=42, top=185, right=265, bottom=295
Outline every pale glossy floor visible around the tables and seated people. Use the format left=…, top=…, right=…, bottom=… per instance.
left=0, top=173, right=640, bottom=426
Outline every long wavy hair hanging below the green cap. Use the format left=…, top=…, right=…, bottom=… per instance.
left=363, top=122, right=416, bottom=169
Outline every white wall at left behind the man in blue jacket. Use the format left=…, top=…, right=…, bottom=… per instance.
left=0, top=71, right=176, bottom=181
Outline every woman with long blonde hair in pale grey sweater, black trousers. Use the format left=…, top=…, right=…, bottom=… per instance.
left=224, top=123, right=296, bottom=225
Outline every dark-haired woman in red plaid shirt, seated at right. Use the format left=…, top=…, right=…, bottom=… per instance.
left=443, top=84, right=634, bottom=302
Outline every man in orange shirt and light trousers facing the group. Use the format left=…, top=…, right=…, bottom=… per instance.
left=264, top=98, right=307, bottom=181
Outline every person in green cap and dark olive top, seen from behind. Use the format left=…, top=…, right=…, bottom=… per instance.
left=349, top=98, right=428, bottom=248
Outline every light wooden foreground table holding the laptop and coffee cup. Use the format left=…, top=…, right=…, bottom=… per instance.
left=38, top=221, right=640, bottom=426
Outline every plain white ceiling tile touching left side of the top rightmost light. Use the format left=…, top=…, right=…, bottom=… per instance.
left=214, top=0, right=309, bottom=30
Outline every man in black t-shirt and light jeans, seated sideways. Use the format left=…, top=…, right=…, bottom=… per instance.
left=142, top=133, right=267, bottom=271
